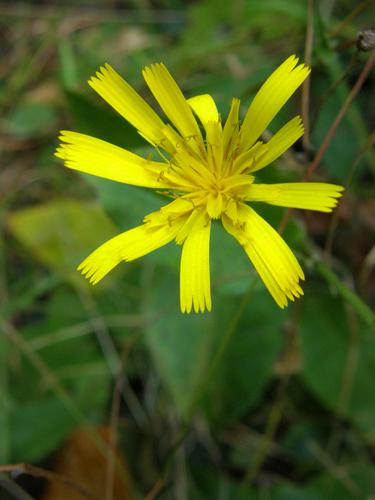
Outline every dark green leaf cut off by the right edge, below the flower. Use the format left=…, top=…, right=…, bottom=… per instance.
left=300, top=285, right=375, bottom=439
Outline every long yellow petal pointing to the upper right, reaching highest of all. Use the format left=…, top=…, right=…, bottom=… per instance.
left=241, top=56, right=310, bottom=149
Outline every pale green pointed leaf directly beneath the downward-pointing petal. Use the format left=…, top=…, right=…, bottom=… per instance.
left=145, top=266, right=213, bottom=415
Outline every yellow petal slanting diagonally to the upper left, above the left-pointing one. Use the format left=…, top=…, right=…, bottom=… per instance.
left=88, top=64, right=164, bottom=144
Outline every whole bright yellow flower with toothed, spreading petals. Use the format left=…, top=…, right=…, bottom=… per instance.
left=55, top=56, right=343, bottom=313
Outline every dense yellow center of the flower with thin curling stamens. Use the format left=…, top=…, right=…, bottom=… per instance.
left=154, top=118, right=266, bottom=219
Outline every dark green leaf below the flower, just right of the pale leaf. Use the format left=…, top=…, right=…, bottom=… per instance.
left=204, top=288, right=287, bottom=424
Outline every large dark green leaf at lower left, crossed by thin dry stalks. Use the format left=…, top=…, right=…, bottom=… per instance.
left=9, top=287, right=111, bottom=461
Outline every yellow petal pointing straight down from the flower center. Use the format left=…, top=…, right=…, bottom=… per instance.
left=180, top=219, right=211, bottom=313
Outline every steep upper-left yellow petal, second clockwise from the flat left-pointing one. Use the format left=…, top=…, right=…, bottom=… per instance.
left=143, top=64, right=202, bottom=144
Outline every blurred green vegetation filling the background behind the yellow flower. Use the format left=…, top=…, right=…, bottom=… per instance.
left=0, top=0, right=375, bottom=500
